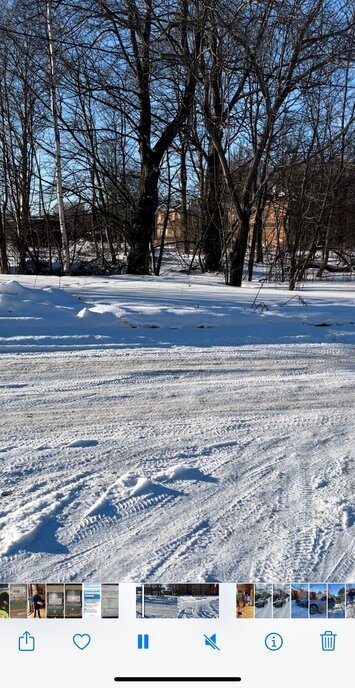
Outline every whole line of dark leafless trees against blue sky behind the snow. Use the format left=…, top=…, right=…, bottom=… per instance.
left=0, top=0, right=355, bottom=289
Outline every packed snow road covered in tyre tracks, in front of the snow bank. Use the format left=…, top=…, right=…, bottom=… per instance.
left=0, top=343, right=355, bottom=582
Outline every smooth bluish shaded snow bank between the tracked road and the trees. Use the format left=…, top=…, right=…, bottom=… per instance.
left=0, top=276, right=355, bottom=351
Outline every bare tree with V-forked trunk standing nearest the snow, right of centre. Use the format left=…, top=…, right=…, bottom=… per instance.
left=204, top=0, right=351, bottom=286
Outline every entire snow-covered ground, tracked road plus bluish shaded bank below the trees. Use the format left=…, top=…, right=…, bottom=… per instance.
left=0, top=274, right=355, bottom=582
